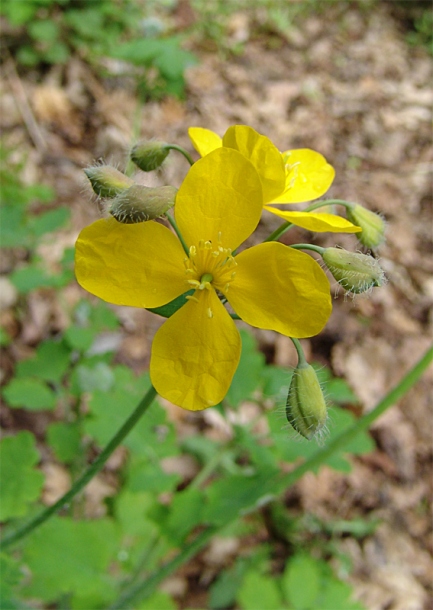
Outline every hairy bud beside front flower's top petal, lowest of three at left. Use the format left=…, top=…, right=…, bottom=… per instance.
left=107, top=184, right=177, bottom=224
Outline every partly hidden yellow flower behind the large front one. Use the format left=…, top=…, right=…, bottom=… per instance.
left=188, top=125, right=361, bottom=233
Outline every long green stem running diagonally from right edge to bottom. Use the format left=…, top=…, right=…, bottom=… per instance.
left=108, top=347, right=433, bottom=610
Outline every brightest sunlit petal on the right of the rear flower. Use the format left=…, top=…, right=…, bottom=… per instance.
left=268, top=148, right=335, bottom=203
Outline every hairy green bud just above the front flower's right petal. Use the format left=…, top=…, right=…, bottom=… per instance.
left=322, top=248, right=386, bottom=294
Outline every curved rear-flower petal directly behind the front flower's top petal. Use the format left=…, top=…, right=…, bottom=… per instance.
left=223, top=125, right=285, bottom=203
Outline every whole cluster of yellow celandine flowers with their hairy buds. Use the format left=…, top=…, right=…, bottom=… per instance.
left=75, top=125, right=385, bottom=439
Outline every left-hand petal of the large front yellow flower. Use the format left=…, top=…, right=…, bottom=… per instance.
left=75, top=218, right=188, bottom=307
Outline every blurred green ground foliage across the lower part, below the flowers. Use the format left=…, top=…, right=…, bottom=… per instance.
left=2, top=324, right=376, bottom=610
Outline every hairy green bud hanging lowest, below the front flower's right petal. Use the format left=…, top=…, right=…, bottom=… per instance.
left=286, top=362, right=327, bottom=441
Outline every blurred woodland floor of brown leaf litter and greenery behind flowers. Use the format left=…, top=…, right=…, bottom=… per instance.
left=0, top=0, right=433, bottom=610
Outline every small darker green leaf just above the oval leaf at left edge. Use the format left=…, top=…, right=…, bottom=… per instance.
left=16, top=340, right=71, bottom=383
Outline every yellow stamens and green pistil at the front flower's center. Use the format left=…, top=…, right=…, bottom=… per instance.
left=184, top=234, right=237, bottom=293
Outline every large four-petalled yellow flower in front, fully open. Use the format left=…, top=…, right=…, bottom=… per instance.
left=76, top=148, right=331, bottom=410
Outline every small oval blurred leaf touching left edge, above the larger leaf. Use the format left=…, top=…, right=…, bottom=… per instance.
left=2, top=377, right=56, bottom=411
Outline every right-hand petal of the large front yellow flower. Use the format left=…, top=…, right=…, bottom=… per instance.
left=225, top=242, right=332, bottom=338
